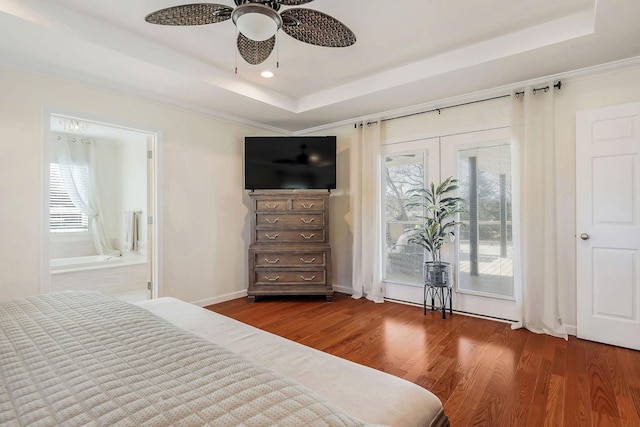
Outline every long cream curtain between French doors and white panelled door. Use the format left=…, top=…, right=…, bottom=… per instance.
left=511, top=83, right=568, bottom=339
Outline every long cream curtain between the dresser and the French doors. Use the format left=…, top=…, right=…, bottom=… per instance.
left=350, top=120, right=384, bottom=303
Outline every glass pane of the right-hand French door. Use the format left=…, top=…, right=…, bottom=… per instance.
left=458, top=143, right=514, bottom=298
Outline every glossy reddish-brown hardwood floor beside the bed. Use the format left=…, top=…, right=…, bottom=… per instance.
left=207, top=294, right=640, bottom=427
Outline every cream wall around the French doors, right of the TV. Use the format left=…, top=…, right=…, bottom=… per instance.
left=323, top=64, right=640, bottom=332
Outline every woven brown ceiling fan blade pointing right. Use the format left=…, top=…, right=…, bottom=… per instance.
left=280, top=8, right=356, bottom=47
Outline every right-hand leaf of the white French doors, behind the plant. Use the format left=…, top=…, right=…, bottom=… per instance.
left=440, top=128, right=520, bottom=320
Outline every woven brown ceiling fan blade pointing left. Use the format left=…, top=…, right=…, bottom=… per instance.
left=144, top=3, right=233, bottom=25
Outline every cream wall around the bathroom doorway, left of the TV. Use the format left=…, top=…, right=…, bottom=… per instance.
left=0, top=67, right=270, bottom=303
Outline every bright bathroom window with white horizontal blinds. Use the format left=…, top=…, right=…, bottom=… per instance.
left=49, top=163, right=89, bottom=233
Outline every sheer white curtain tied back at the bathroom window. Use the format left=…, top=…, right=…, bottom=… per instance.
left=52, top=137, right=120, bottom=256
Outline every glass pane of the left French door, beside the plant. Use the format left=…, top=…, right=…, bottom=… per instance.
left=382, top=152, right=425, bottom=285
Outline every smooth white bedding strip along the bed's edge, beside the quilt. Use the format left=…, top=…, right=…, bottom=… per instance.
left=140, top=298, right=448, bottom=427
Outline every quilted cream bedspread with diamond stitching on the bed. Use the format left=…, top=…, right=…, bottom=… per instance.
left=0, top=292, right=378, bottom=426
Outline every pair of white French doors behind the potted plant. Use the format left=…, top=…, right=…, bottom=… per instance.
left=381, top=128, right=519, bottom=320
